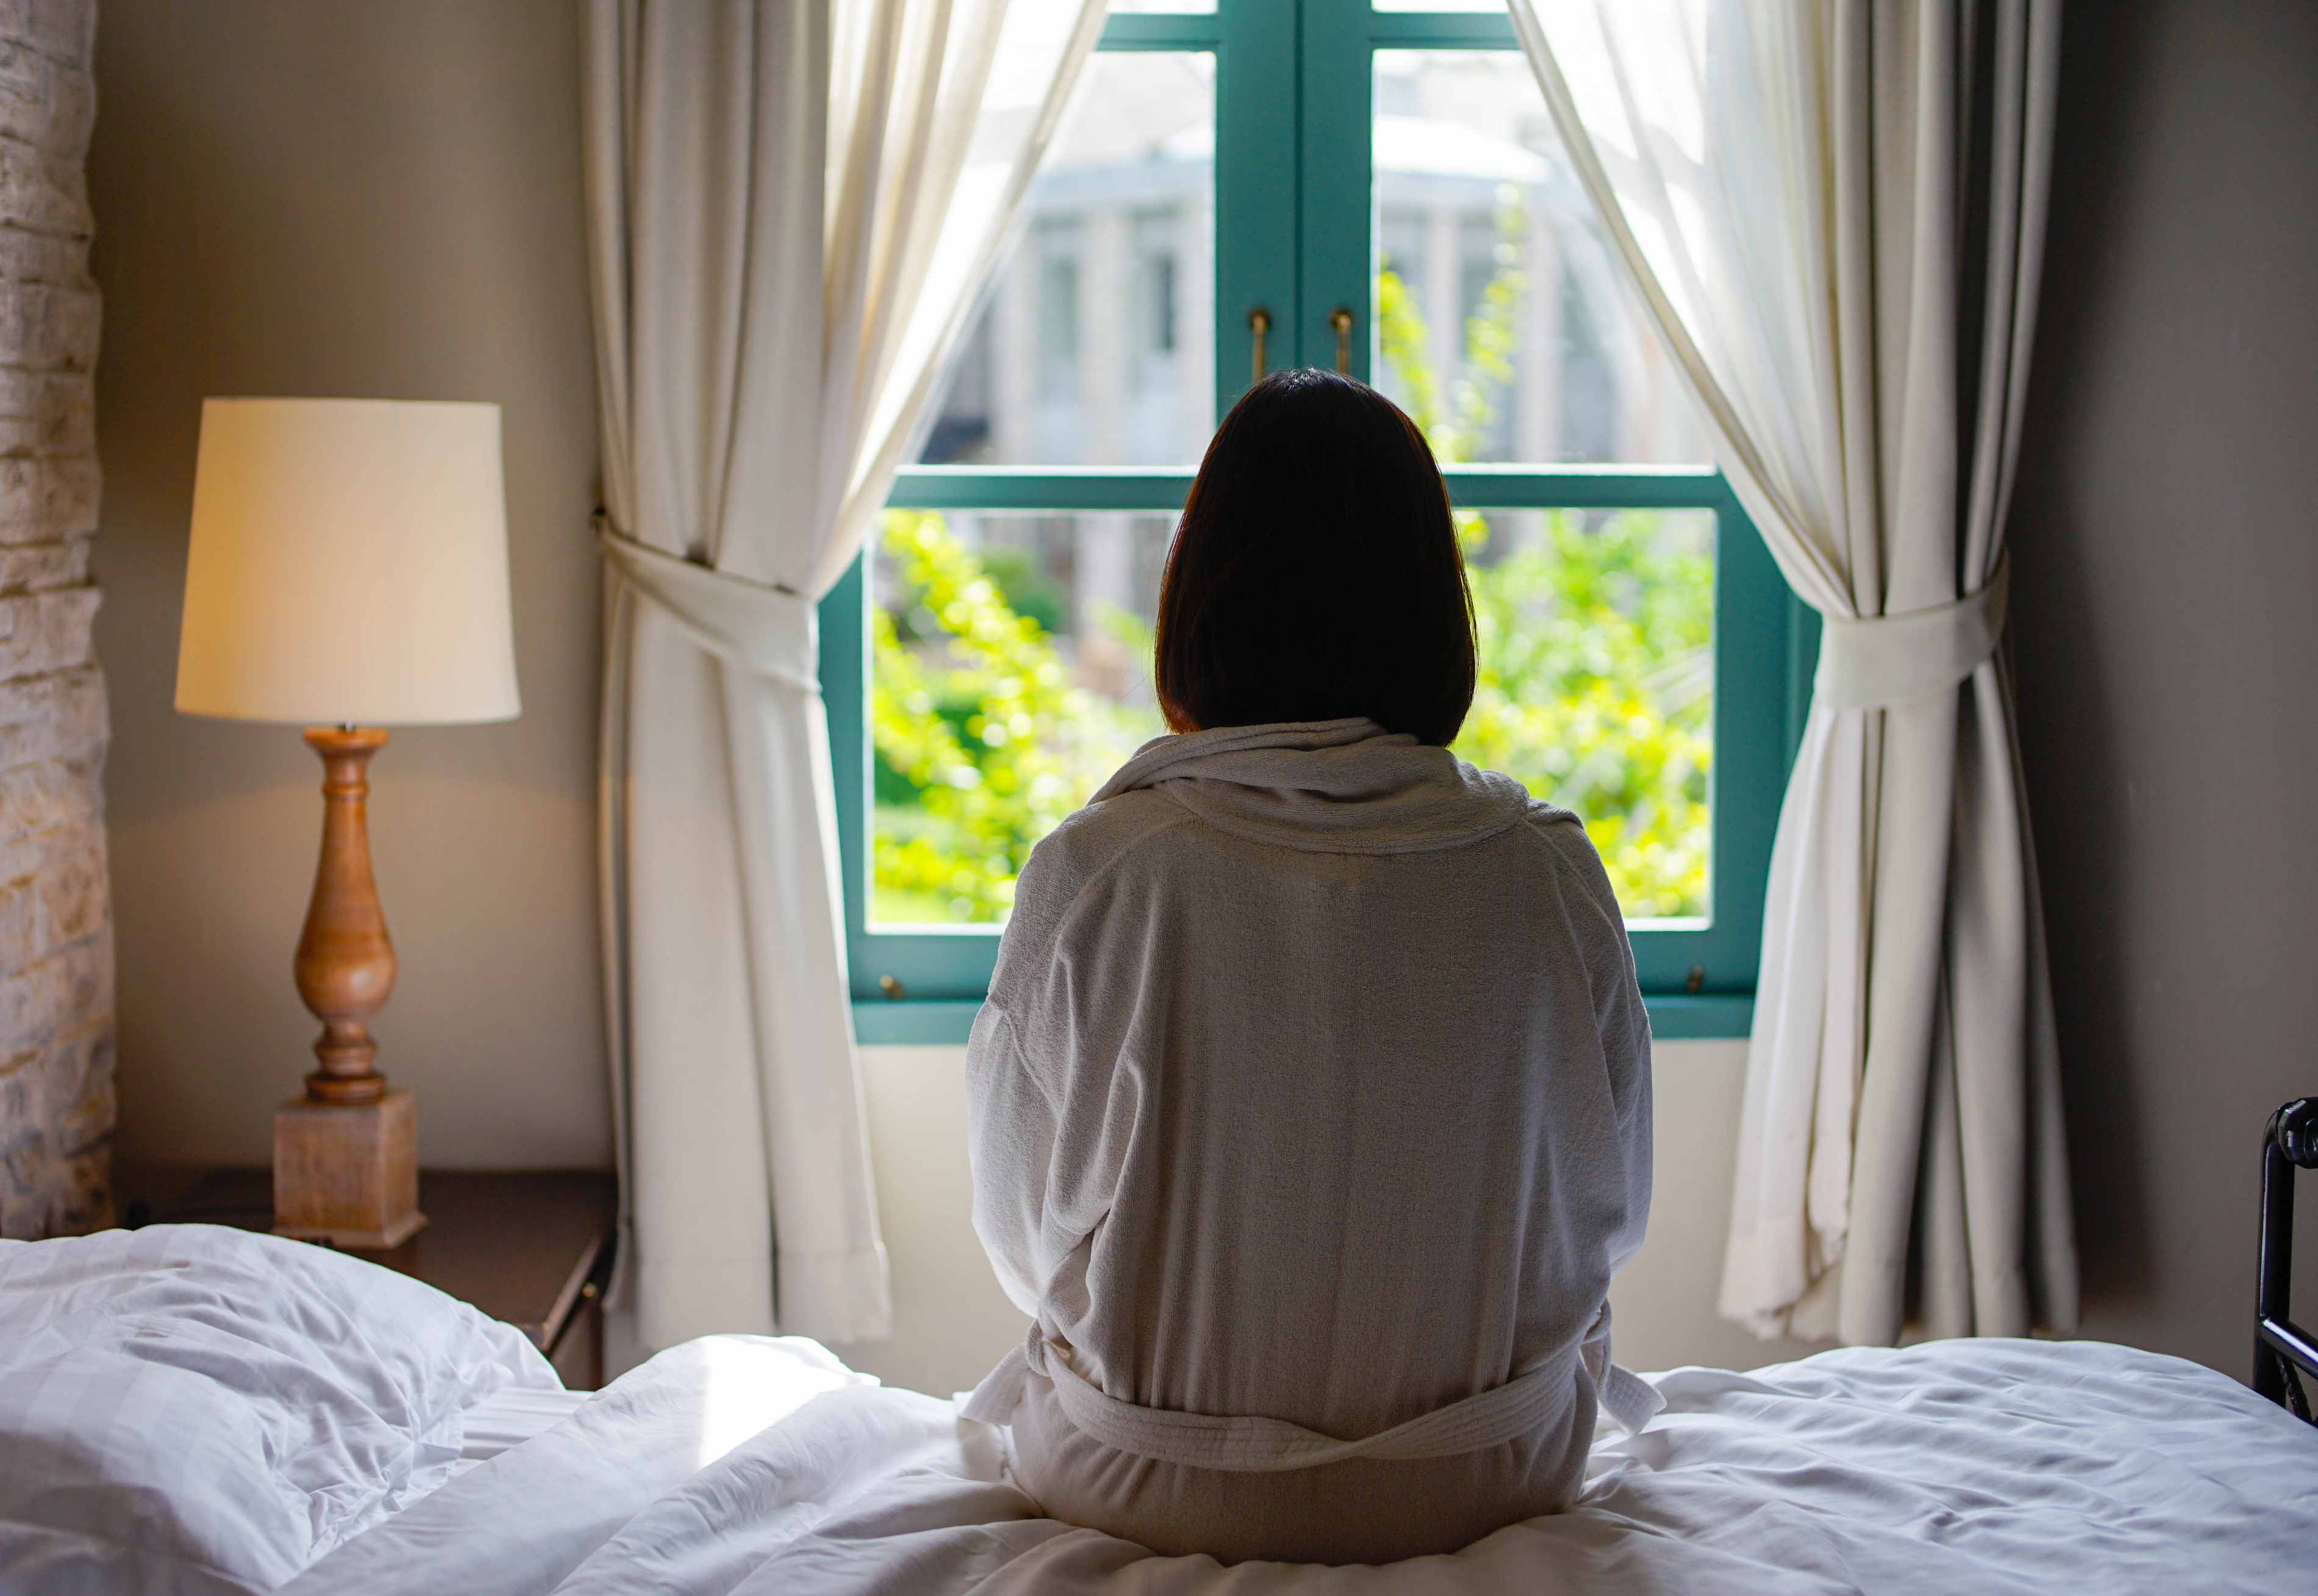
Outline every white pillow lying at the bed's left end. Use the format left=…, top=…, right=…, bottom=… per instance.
left=0, top=1225, right=561, bottom=1596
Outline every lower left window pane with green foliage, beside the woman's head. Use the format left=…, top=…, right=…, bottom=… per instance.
left=869, top=497, right=1175, bottom=927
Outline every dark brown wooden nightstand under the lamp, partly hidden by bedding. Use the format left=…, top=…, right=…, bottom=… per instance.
left=151, top=1170, right=619, bottom=1390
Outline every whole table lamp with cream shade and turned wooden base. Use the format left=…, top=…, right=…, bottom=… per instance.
left=176, top=399, right=519, bottom=1249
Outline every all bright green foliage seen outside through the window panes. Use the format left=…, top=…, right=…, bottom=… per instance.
left=869, top=199, right=1713, bottom=924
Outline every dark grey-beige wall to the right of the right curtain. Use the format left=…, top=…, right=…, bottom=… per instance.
left=2012, top=0, right=2318, bottom=1376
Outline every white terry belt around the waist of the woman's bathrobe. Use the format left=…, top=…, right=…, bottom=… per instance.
left=962, top=1304, right=1664, bottom=1473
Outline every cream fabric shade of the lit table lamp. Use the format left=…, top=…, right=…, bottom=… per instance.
left=176, top=399, right=521, bottom=725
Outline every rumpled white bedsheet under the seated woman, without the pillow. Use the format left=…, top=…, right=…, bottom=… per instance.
left=290, top=1336, right=2318, bottom=1596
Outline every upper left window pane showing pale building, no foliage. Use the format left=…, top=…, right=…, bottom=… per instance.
left=920, top=51, right=1214, bottom=466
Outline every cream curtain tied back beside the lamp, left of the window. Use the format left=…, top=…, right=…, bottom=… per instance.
left=582, top=0, right=1104, bottom=1346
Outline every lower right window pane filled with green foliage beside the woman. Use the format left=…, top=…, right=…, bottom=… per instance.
left=1451, top=510, right=1715, bottom=922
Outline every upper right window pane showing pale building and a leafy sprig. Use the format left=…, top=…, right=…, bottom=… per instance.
left=1375, top=51, right=1708, bottom=466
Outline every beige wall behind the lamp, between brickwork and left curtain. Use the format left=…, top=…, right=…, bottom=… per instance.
left=90, top=0, right=610, bottom=1167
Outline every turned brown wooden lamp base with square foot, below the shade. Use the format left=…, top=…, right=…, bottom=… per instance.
left=274, top=725, right=427, bottom=1251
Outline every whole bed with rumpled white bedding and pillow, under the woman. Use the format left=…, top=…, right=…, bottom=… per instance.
left=13, top=1225, right=2318, bottom=1596
